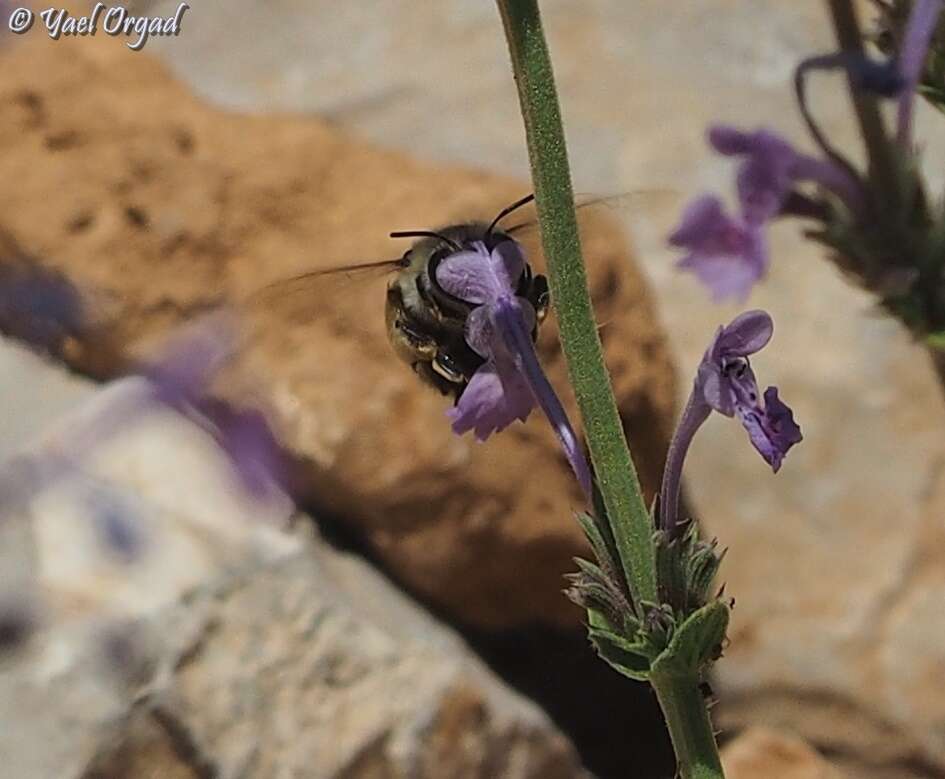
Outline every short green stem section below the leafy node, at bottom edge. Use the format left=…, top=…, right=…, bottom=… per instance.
left=650, top=674, right=725, bottom=779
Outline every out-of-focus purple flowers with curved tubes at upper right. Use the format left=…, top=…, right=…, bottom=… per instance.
left=669, top=0, right=945, bottom=301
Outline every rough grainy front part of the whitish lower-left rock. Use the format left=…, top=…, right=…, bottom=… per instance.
left=88, top=551, right=583, bottom=779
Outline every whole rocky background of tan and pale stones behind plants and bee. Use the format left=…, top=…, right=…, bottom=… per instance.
left=0, top=0, right=945, bottom=778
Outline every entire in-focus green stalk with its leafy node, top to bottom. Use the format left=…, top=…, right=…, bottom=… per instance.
left=497, top=0, right=728, bottom=779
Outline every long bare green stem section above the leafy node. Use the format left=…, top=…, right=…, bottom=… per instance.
left=497, top=0, right=657, bottom=602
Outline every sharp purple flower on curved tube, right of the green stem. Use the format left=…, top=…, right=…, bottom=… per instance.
left=660, top=311, right=802, bottom=532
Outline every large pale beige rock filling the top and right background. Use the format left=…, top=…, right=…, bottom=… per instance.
left=135, top=0, right=945, bottom=779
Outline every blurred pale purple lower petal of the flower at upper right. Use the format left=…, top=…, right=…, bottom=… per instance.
left=669, top=195, right=768, bottom=302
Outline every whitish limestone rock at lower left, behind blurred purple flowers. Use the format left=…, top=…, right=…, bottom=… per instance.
left=0, top=344, right=584, bottom=779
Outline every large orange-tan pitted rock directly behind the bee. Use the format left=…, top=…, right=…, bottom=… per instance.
left=0, top=37, right=674, bottom=626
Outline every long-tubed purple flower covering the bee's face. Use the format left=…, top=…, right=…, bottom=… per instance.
left=436, top=240, right=591, bottom=499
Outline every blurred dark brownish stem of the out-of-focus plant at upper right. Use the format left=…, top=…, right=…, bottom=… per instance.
left=827, top=0, right=899, bottom=206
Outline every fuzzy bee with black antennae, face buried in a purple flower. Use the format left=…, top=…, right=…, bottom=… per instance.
left=256, top=195, right=549, bottom=401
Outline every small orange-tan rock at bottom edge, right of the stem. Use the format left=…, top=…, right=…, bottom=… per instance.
left=722, top=728, right=846, bottom=779
